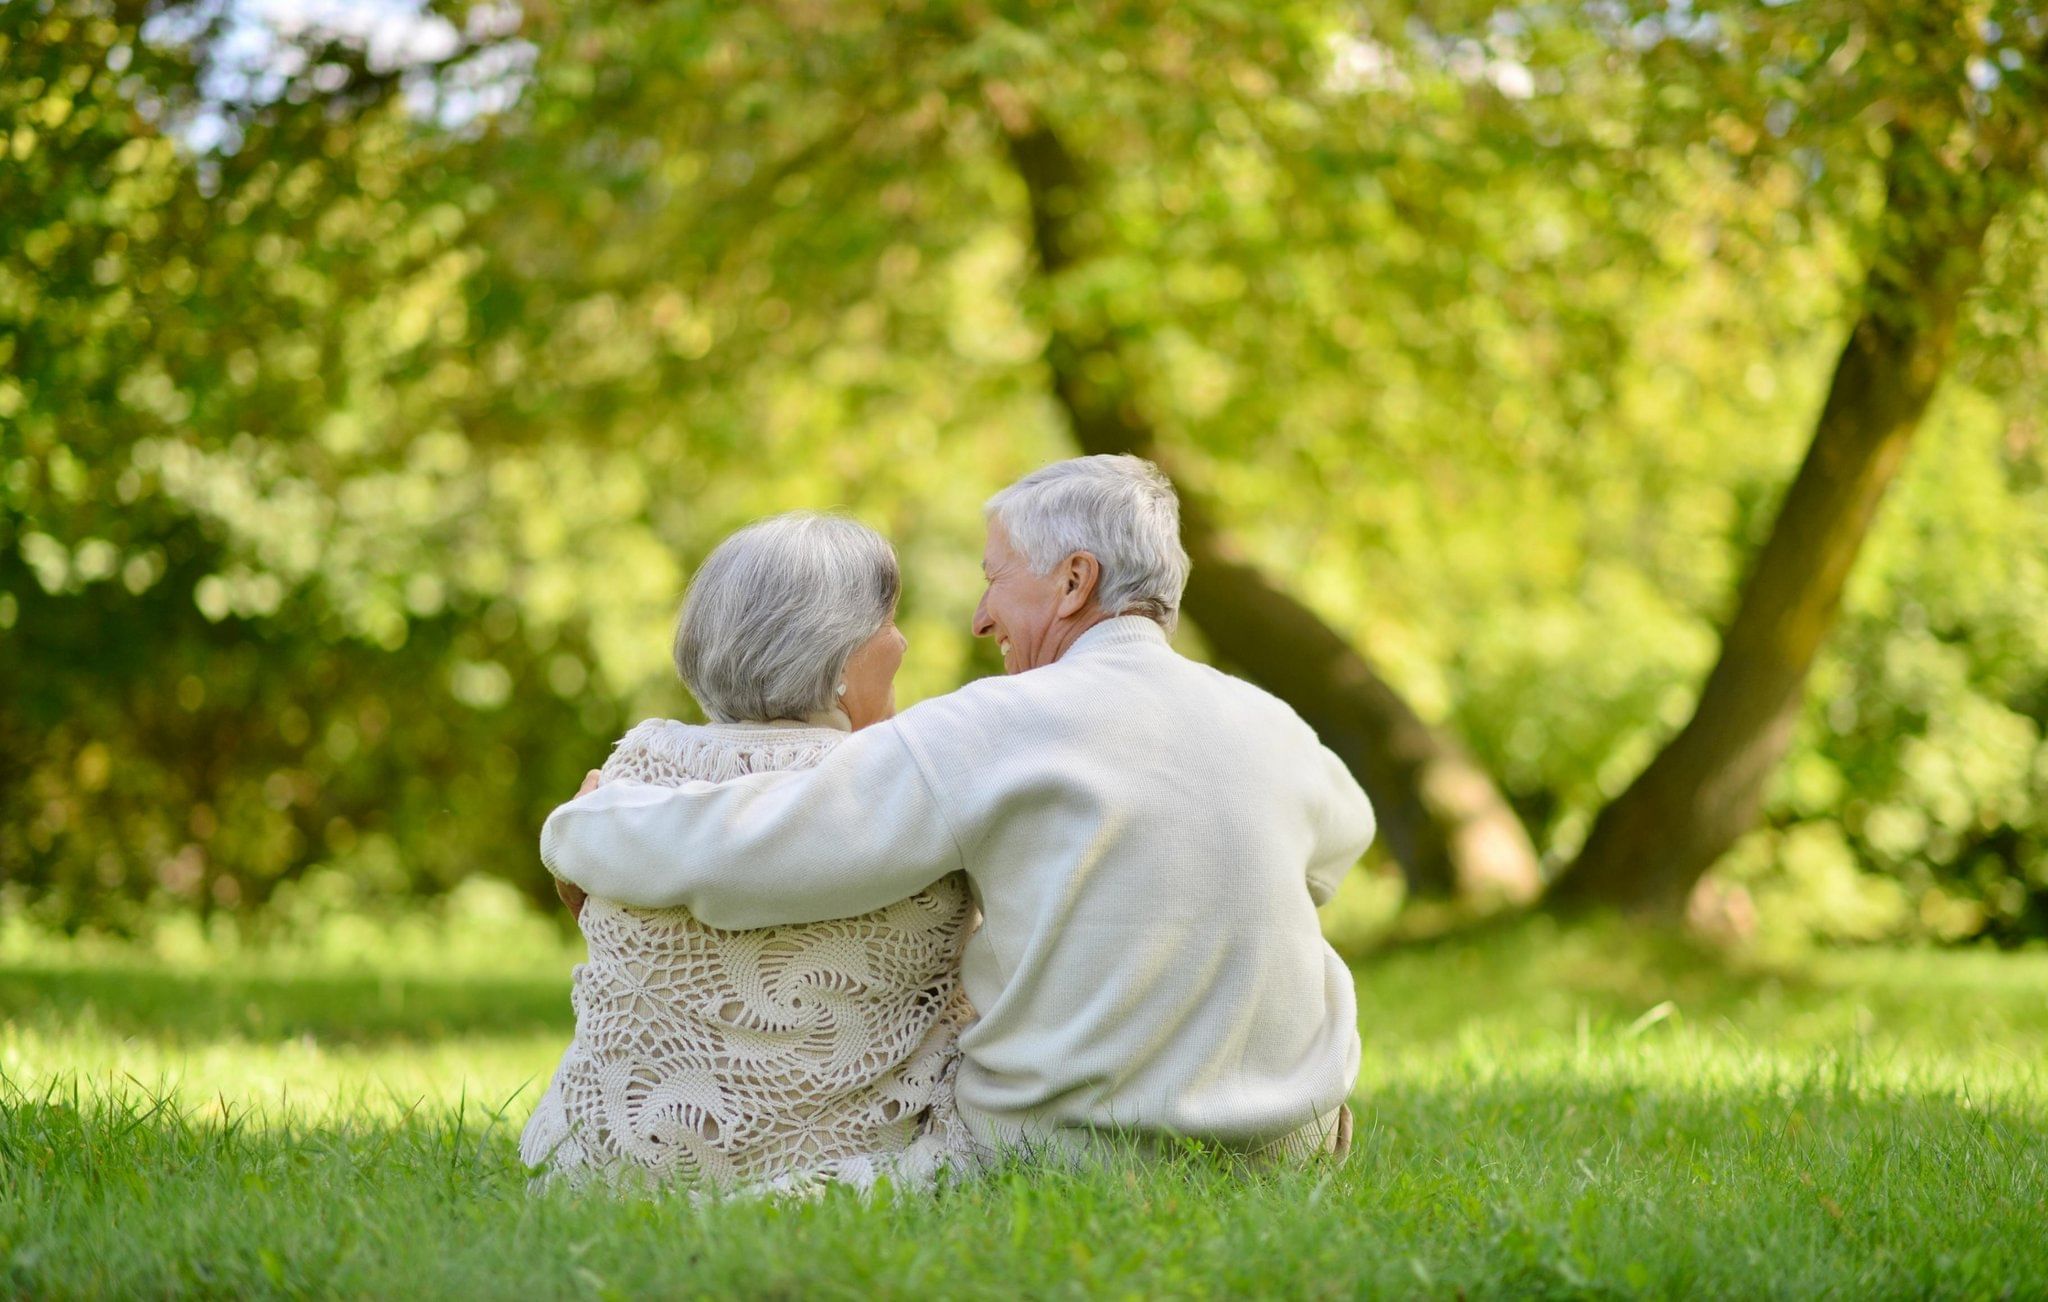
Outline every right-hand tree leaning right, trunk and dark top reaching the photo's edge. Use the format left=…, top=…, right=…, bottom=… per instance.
left=1548, top=4, right=2048, bottom=915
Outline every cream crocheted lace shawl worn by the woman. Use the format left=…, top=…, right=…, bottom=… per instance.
left=520, top=719, right=979, bottom=1189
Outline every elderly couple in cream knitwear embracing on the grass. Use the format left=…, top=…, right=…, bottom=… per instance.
left=520, top=457, right=1374, bottom=1189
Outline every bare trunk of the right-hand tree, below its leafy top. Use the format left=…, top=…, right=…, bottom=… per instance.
left=1548, top=131, right=1991, bottom=915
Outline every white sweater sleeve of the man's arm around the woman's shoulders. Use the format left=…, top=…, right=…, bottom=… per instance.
left=541, top=723, right=963, bottom=929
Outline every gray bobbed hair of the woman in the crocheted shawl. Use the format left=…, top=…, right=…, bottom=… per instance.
left=676, top=512, right=903, bottom=723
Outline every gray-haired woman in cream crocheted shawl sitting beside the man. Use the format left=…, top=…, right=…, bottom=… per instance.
left=520, top=514, right=975, bottom=1189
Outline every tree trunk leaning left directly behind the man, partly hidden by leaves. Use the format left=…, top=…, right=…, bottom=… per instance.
left=987, top=86, right=1542, bottom=903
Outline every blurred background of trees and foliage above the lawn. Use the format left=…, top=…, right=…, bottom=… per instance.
left=12, top=0, right=2048, bottom=944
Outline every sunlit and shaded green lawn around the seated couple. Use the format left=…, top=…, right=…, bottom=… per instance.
left=0, top=904, right=2048, bottom=1298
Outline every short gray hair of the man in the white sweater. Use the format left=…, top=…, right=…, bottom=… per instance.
left=983, top=457, right=1188, bottom=633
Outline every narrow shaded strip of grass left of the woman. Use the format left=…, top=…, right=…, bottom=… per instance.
left=0, top=966, right=573, bottom=1044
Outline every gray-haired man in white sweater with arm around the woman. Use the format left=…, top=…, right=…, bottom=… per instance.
left=541, top=457, right=1374, bottom=1159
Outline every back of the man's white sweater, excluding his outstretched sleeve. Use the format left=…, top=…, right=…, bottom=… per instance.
left=897, top=618, right=1372, bottom=1144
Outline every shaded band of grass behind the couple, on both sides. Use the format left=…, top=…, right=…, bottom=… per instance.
left=16, top=917, right=2048, bottom=1056
